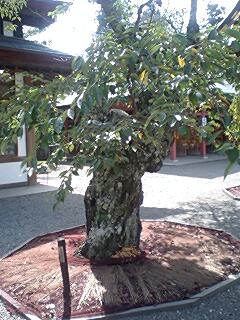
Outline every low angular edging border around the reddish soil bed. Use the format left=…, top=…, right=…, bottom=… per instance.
left=0, top=219, right=240, bottom=320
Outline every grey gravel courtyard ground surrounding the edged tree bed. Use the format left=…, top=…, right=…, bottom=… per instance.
left=0, top=161, right=240, bottom=320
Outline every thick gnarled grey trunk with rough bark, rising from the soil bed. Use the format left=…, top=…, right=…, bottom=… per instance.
left=77, top=165, right=144, bottom=260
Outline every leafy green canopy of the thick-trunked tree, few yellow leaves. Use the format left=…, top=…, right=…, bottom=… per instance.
left=2, top=0, right=239, bottom=175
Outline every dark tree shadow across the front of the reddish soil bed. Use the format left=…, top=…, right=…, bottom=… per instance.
left=83, top=252, right=221, bottom=313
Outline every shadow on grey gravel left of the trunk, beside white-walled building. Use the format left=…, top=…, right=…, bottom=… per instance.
left=0, top=192, right=85, bottom=257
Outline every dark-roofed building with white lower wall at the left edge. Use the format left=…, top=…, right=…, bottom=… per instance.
left=0, top=0, right=73, bottom=188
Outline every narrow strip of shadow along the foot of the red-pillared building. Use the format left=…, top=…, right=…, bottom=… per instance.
left=158, top=160, right=239, bottom=179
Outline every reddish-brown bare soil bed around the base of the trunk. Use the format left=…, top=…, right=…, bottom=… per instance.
left=0, top=221, right=240, bottom=319
